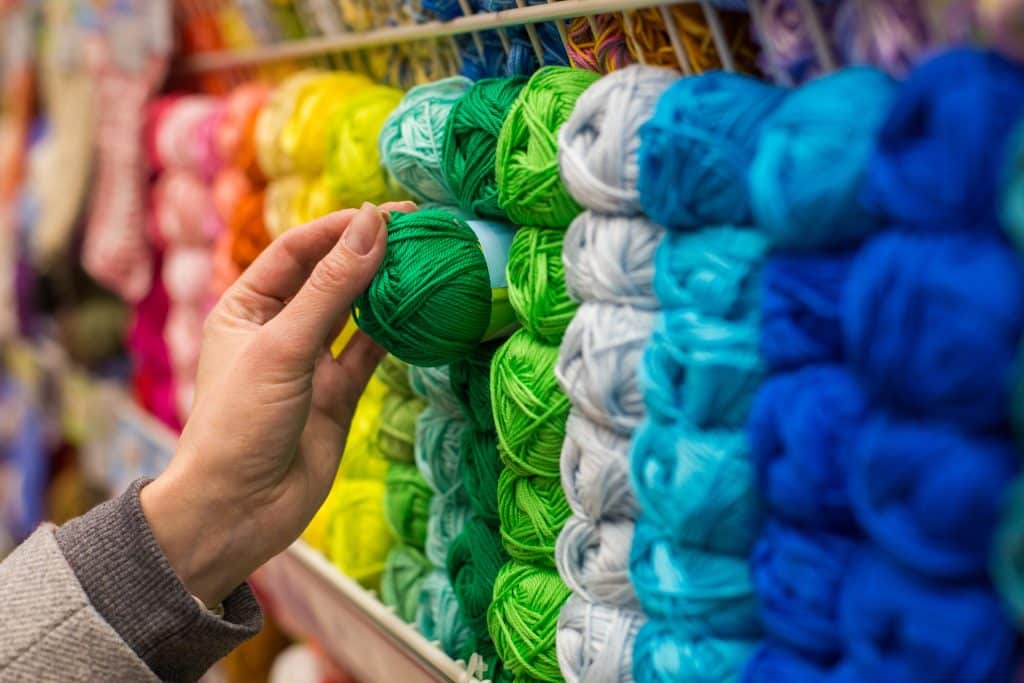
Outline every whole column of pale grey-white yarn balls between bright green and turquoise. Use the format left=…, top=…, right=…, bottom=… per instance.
left=555, top=66, right=678, bottom=683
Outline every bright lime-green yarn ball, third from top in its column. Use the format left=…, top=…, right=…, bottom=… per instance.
left=490, top=330, right=569, bottom=477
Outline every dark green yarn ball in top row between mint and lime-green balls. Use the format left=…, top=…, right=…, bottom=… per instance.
left=441, top=77, right=526, bottom=219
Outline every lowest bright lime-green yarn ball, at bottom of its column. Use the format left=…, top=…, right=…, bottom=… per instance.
left=487, top=560, right=570, bottom=681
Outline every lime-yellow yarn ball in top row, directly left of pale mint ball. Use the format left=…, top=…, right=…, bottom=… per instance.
left=324, top=85, right=406, bottom=208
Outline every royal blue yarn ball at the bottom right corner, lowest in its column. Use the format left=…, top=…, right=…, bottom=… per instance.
left=840, top=550, right=1017, bottom=683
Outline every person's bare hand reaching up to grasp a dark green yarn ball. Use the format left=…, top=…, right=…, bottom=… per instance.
left=141, top=203, right=416, bottom=605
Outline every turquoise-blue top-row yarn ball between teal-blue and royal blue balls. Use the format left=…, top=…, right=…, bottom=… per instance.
left=749, top=67, right=896, bottom=250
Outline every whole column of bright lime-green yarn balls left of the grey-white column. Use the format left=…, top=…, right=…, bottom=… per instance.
left=487, top=67, right=597, bottom=681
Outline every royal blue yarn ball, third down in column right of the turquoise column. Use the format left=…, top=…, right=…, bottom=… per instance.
left=746, top=366, right=868, bottom=530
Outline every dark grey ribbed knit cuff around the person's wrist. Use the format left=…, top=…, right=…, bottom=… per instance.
left=56, top=480, right=262, bottom=681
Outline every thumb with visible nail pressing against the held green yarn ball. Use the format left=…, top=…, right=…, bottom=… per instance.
left=263, top=203, right=387, bottom=362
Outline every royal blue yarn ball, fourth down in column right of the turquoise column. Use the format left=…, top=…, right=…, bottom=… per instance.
left=751, top=521, right=859, bottom=664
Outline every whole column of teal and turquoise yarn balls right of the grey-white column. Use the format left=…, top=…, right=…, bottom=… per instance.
left=629, top=68, right=783, bottom=681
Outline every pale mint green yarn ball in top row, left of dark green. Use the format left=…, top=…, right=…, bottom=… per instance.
left=379, top=76, right=472, bottom=204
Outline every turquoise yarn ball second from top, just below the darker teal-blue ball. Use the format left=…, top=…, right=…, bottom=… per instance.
left=654, top=227, right=767, bottom=321
